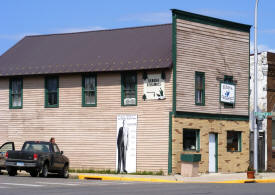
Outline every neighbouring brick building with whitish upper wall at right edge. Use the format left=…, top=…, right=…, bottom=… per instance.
left=250, top=52, right=275, bottom=171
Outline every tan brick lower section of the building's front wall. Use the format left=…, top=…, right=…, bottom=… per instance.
left=172, top=117, right=249, bottom=173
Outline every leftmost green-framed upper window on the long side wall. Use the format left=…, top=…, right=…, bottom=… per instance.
left=9, top=78, right=23, bottom=109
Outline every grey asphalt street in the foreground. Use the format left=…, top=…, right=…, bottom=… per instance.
left=0, top=175, right=275, bottom=195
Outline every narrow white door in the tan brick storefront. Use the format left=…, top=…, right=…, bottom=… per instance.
left=209, top=133, right=218, bottom=173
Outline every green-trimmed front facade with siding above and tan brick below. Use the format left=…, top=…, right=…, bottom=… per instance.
left=170, top=10, right=253, bottom=173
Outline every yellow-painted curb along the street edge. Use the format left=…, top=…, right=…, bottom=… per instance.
left=78, top=175, right=275, bottom=184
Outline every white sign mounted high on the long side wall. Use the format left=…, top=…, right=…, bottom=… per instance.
left=144, top=74, right=165, bottom=100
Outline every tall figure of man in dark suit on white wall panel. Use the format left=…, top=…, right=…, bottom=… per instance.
left=117, top=120, right=129, bottom=173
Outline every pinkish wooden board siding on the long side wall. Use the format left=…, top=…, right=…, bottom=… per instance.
left=0, top=70, right=172, bottom=172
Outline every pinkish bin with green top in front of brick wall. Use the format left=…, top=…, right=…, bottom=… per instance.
left=180, top=154, right=201, bottom=177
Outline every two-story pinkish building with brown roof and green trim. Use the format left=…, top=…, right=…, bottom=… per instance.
left=0, top=10, right=250, bottom=173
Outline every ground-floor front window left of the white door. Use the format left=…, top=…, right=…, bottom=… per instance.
left=183, top=129, right=200, bottom=151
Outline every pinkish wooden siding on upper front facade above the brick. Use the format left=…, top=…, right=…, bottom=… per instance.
left=176, top=19, right=249, bottom=115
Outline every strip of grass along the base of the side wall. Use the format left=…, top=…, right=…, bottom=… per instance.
left=69, top=169, right=164, bottom=175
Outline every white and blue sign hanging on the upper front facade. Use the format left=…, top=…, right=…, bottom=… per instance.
left=220, top=83, right=236, bottom=104
